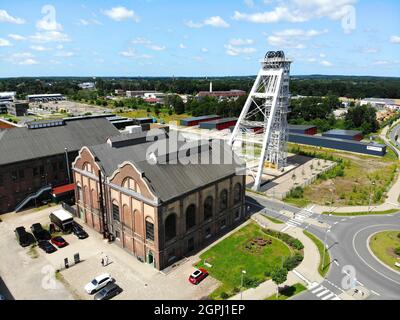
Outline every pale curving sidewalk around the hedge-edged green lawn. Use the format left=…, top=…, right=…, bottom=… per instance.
left=230, top=213, right=324, bottom=300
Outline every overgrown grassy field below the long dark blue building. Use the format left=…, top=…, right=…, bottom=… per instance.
left=285, top=144, right=398, bottom=206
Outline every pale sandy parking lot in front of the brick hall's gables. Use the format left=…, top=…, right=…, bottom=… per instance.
left=0, top=207, right=218, bottom=300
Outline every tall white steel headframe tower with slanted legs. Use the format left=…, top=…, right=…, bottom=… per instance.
left=229, top=51, right=291, bottom=190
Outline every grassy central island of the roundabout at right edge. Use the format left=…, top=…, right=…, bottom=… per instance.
left=369, top=230, right=400, bottom=271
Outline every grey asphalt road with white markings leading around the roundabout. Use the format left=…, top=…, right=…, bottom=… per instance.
left=247, top=195, right=400, bottom=300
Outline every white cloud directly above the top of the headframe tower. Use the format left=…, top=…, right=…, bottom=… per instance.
left=267, top=29, right=328, bottom=49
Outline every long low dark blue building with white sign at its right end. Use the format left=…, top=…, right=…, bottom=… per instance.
left=289, top=133, right=386, bottom=157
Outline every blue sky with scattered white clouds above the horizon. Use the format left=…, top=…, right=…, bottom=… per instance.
left=0, top=0, right=400, bottom=77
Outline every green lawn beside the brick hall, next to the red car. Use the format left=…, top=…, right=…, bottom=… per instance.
left=197, top=223, right=294, bottom=299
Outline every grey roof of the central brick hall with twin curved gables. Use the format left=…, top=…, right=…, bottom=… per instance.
left=90, top=134, right=244, bottom=202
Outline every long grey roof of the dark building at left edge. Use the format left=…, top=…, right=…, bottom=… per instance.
left=0, top=118, right=120, bottom=165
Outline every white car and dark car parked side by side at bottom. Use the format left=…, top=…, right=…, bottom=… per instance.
left=85, top=273, right=123, bottom=300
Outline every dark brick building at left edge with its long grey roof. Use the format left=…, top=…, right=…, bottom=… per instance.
left=0, top=118, right=119, bottom=213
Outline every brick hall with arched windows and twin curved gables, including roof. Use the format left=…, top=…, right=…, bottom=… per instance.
left=73, top=130, right=245, bottom=270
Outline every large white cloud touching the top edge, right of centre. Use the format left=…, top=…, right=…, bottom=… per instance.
left=233, top=0, right=357, bottom=23
